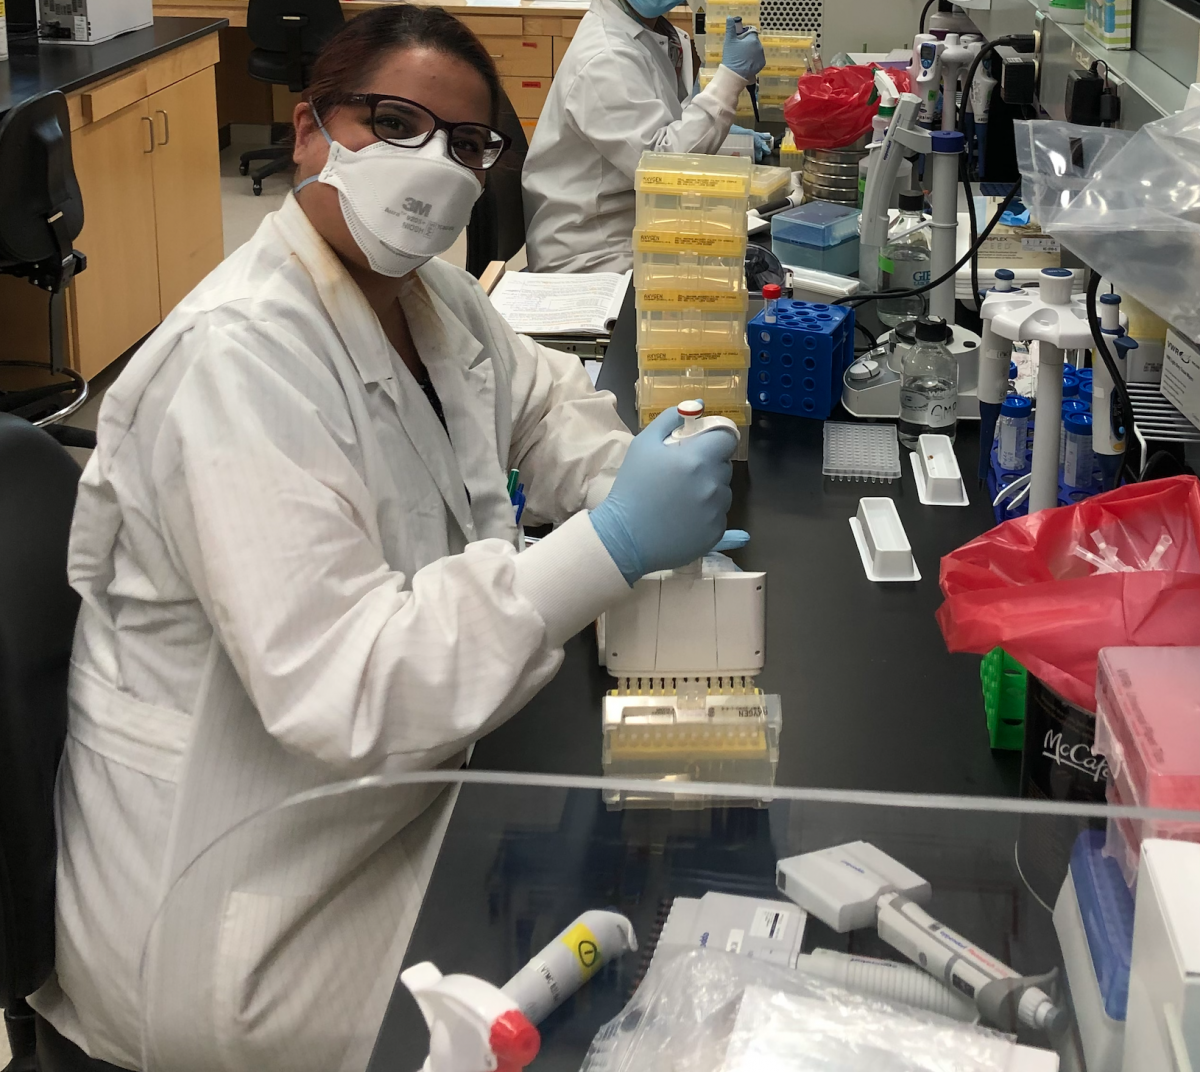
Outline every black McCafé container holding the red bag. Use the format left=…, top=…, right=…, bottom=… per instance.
left=1016, top=673, right=1109, bottom=905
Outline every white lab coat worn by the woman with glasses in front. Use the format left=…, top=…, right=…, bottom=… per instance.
left=34, top=197, right=630, bottom=1072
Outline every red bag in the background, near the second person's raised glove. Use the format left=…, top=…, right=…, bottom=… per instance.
left=784, top=64, right=910, bottom=149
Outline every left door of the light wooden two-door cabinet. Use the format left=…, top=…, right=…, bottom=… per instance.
left=67, top=100, right=160, bottom=379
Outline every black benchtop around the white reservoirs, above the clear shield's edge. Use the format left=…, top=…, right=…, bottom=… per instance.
left=472, top=292, right=1020, bottom=796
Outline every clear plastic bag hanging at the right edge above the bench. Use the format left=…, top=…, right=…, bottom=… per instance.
left=1016, top=108, right=1200, bottom=339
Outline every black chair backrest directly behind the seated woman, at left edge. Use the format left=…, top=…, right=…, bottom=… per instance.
left=0, top=413, right=79, bottom=1008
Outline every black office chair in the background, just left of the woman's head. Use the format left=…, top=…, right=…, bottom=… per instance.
left=239, top=0, right=346, bottom=196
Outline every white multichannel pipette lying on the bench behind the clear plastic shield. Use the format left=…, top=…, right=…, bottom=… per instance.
left=775, top=842, right=1067, bottom=1036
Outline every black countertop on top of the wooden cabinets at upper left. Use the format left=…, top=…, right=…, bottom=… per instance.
left=0, top=18, right=229, bottom=115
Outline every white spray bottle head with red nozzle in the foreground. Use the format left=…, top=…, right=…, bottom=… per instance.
left=400, top=960, right=541, bottom=1072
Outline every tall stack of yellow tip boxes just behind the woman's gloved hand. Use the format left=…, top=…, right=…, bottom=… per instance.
left=634, top=152, right=752, bottom=459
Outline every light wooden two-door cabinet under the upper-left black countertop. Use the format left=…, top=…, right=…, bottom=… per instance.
left=0, top=34, right=224, bottom=379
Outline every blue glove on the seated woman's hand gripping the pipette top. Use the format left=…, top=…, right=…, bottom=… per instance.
left=592, top=406, right=737, bottom=585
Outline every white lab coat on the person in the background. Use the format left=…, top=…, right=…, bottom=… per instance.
left=522, top=0, right=746, bottom=271
